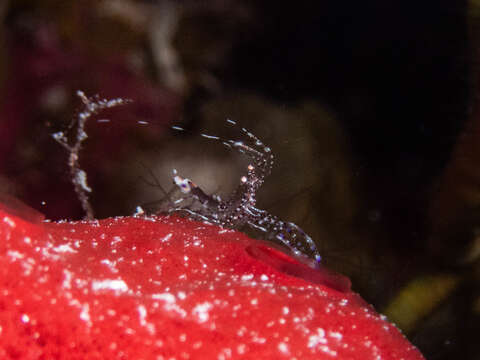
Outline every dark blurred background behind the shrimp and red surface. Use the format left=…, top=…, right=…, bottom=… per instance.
left=0, top=0, right=480, bottom=359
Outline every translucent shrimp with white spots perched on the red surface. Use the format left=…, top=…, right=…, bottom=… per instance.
left=170, top=120, right=321, bottom=264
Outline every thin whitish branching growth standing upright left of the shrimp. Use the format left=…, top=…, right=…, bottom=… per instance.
left=52, top=90, right=131, bottom=219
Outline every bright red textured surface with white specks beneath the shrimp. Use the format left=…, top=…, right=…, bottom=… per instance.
left=0, top=207, right=423, bottom=360
